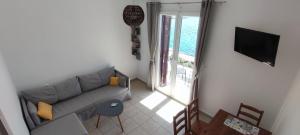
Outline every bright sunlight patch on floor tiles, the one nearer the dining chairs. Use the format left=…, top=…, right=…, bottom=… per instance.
left=156, top=100, right=184, bottom=123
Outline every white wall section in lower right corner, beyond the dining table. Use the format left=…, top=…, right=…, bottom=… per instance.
left=273, top=70, right=300, bottom=135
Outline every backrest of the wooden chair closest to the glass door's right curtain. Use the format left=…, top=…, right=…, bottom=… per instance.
left=188, top=98, right=199, bottom=128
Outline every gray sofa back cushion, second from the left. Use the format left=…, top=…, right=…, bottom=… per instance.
left=54, top=77, right=81, bottom=101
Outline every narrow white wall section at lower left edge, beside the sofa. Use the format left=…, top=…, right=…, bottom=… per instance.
left=0, top=53, right=29, bottom=135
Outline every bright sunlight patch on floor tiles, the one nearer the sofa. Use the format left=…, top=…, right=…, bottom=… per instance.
left=140, top=91, right=167, bottom=110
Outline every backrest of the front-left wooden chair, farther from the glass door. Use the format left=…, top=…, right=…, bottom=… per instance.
left=173, top=108, right=188, bottom=135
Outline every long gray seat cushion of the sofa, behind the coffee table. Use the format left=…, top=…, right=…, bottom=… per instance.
left=53, top=86, right=130, bottom=119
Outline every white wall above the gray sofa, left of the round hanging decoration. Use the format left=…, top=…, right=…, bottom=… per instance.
left=0, top=0, right=137, bottom=90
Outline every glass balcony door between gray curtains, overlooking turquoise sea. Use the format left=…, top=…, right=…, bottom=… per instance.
left=157, top=13, right=199, bottom=104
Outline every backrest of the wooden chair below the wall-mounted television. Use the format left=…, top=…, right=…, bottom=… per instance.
left=237, top=103, right=264, bottom=126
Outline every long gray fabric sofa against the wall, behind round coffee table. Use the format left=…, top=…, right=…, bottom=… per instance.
left=20, top=67, right=131, bottom=131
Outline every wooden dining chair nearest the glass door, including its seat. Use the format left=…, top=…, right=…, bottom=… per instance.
left=188, top=98, right=208, bottom=135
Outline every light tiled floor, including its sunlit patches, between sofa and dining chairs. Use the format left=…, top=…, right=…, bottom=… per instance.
left=83, top=80, right=209, bottom=135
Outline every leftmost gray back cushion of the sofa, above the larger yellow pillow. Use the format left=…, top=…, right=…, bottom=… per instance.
left=22, top=86, right=58, bottom=104
